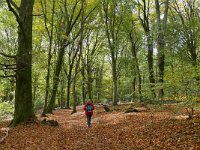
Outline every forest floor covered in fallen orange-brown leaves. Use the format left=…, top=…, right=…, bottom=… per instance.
left=0, top=105, right=200, bottom=150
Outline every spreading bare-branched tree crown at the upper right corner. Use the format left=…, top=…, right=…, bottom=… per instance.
left=171, top=0, right=200, bottom=81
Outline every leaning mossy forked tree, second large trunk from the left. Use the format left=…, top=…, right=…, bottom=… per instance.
left=46, top=0, right=82, bottom=113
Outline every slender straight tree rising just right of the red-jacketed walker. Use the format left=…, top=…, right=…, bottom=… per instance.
left=103, top=0, right=119, bottom=105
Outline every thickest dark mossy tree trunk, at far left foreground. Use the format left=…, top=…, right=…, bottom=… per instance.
left=6, top=0, right=35, bottom=127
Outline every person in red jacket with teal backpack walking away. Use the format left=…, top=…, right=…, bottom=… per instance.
left=83, top=100, right=94, bottom=127
